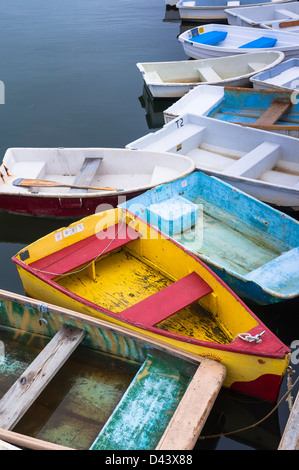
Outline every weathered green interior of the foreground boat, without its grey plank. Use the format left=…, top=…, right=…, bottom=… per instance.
left=0, top=298, right=198, bottom=450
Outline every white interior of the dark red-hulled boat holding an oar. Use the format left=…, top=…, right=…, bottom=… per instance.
left=0, top=148, right=194, bottom=197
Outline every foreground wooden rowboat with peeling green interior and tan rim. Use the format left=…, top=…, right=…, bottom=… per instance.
left=0, top=290, right=225, bottom=450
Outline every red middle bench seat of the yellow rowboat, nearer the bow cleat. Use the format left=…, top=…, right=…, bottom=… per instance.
left=119, top=272, right=213, bottom=326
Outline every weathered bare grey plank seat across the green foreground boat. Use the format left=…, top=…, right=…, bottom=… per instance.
left=0, top=325, right=85, bottom=429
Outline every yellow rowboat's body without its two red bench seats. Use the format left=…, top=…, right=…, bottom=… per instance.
left=13, top=209, right=289, bottom=401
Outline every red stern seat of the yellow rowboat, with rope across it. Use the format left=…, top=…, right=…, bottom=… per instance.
left=30, top=224, right=140, bottom=280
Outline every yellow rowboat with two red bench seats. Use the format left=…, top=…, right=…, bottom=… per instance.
left=13, top=208, right=290, bottom=402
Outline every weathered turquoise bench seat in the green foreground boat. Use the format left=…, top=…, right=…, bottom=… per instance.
left=90, top=356, right=189, bottom=450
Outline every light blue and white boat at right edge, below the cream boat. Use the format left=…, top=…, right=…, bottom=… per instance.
left=250, top=59, right=299, bottom=93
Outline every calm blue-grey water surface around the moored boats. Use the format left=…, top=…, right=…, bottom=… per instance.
left=0, top=0, right=299, bottom=450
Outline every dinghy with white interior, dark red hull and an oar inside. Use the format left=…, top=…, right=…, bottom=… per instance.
left=0, top=148, right=194, bottom=217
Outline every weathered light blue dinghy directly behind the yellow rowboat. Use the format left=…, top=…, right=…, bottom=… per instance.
left=120, top=171, right=299, bottom=305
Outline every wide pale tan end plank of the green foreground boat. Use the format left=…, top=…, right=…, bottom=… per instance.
left=156, top=360, right=226, bottom=450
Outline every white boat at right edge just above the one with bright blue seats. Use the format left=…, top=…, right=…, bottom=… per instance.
left=225, top=2, right=299, bottom=33
